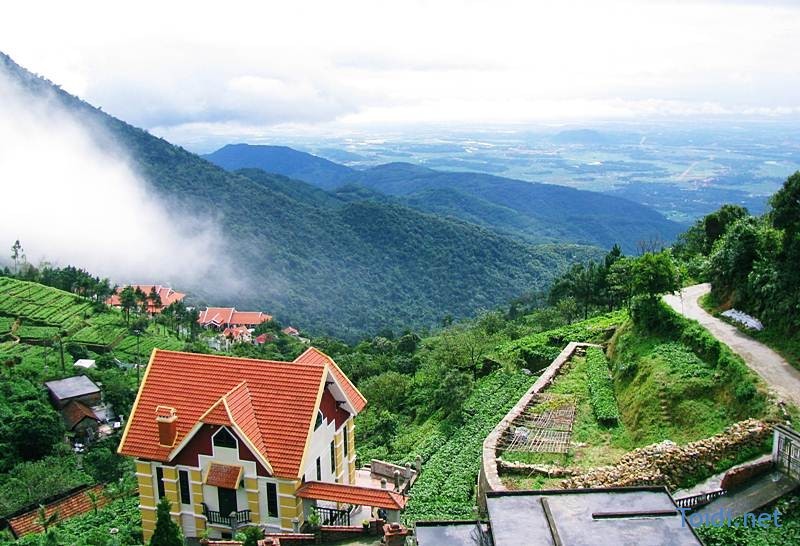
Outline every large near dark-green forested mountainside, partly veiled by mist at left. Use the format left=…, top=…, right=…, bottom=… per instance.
left=0, top=56, right=597, bottom=339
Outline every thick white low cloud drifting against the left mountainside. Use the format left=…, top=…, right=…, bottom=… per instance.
left=0, top=68, right=235, bottom=294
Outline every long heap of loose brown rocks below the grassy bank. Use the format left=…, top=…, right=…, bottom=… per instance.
left=561, top=419, right=772, bottom=490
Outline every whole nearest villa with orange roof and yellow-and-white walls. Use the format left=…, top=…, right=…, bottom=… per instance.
left=119, top=348, right=405, bottom=541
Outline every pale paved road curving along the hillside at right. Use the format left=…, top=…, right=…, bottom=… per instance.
left=664, top=283, right=800, bottom=407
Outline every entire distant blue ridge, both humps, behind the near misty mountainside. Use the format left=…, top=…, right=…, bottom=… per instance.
left=205, top=144, right=682, bottom=251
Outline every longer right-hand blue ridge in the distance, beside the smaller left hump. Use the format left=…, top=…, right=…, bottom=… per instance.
left=354, top=163, right=681, bottom=251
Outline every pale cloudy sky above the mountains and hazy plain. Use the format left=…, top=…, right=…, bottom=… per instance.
left=0, top=0, right=800, bottom=151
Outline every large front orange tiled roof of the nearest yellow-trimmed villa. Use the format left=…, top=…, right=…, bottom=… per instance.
left=119, top=349, right=341, bottom=478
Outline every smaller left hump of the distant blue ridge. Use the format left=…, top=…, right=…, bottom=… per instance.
left=203, top=144, right=353, bottom=189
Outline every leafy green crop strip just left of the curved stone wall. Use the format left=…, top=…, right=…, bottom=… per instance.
left=404, top=370, right=533, bottom=521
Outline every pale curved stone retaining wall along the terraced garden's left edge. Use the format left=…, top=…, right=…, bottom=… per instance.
left=478, top=342, right=600, bottom=511
